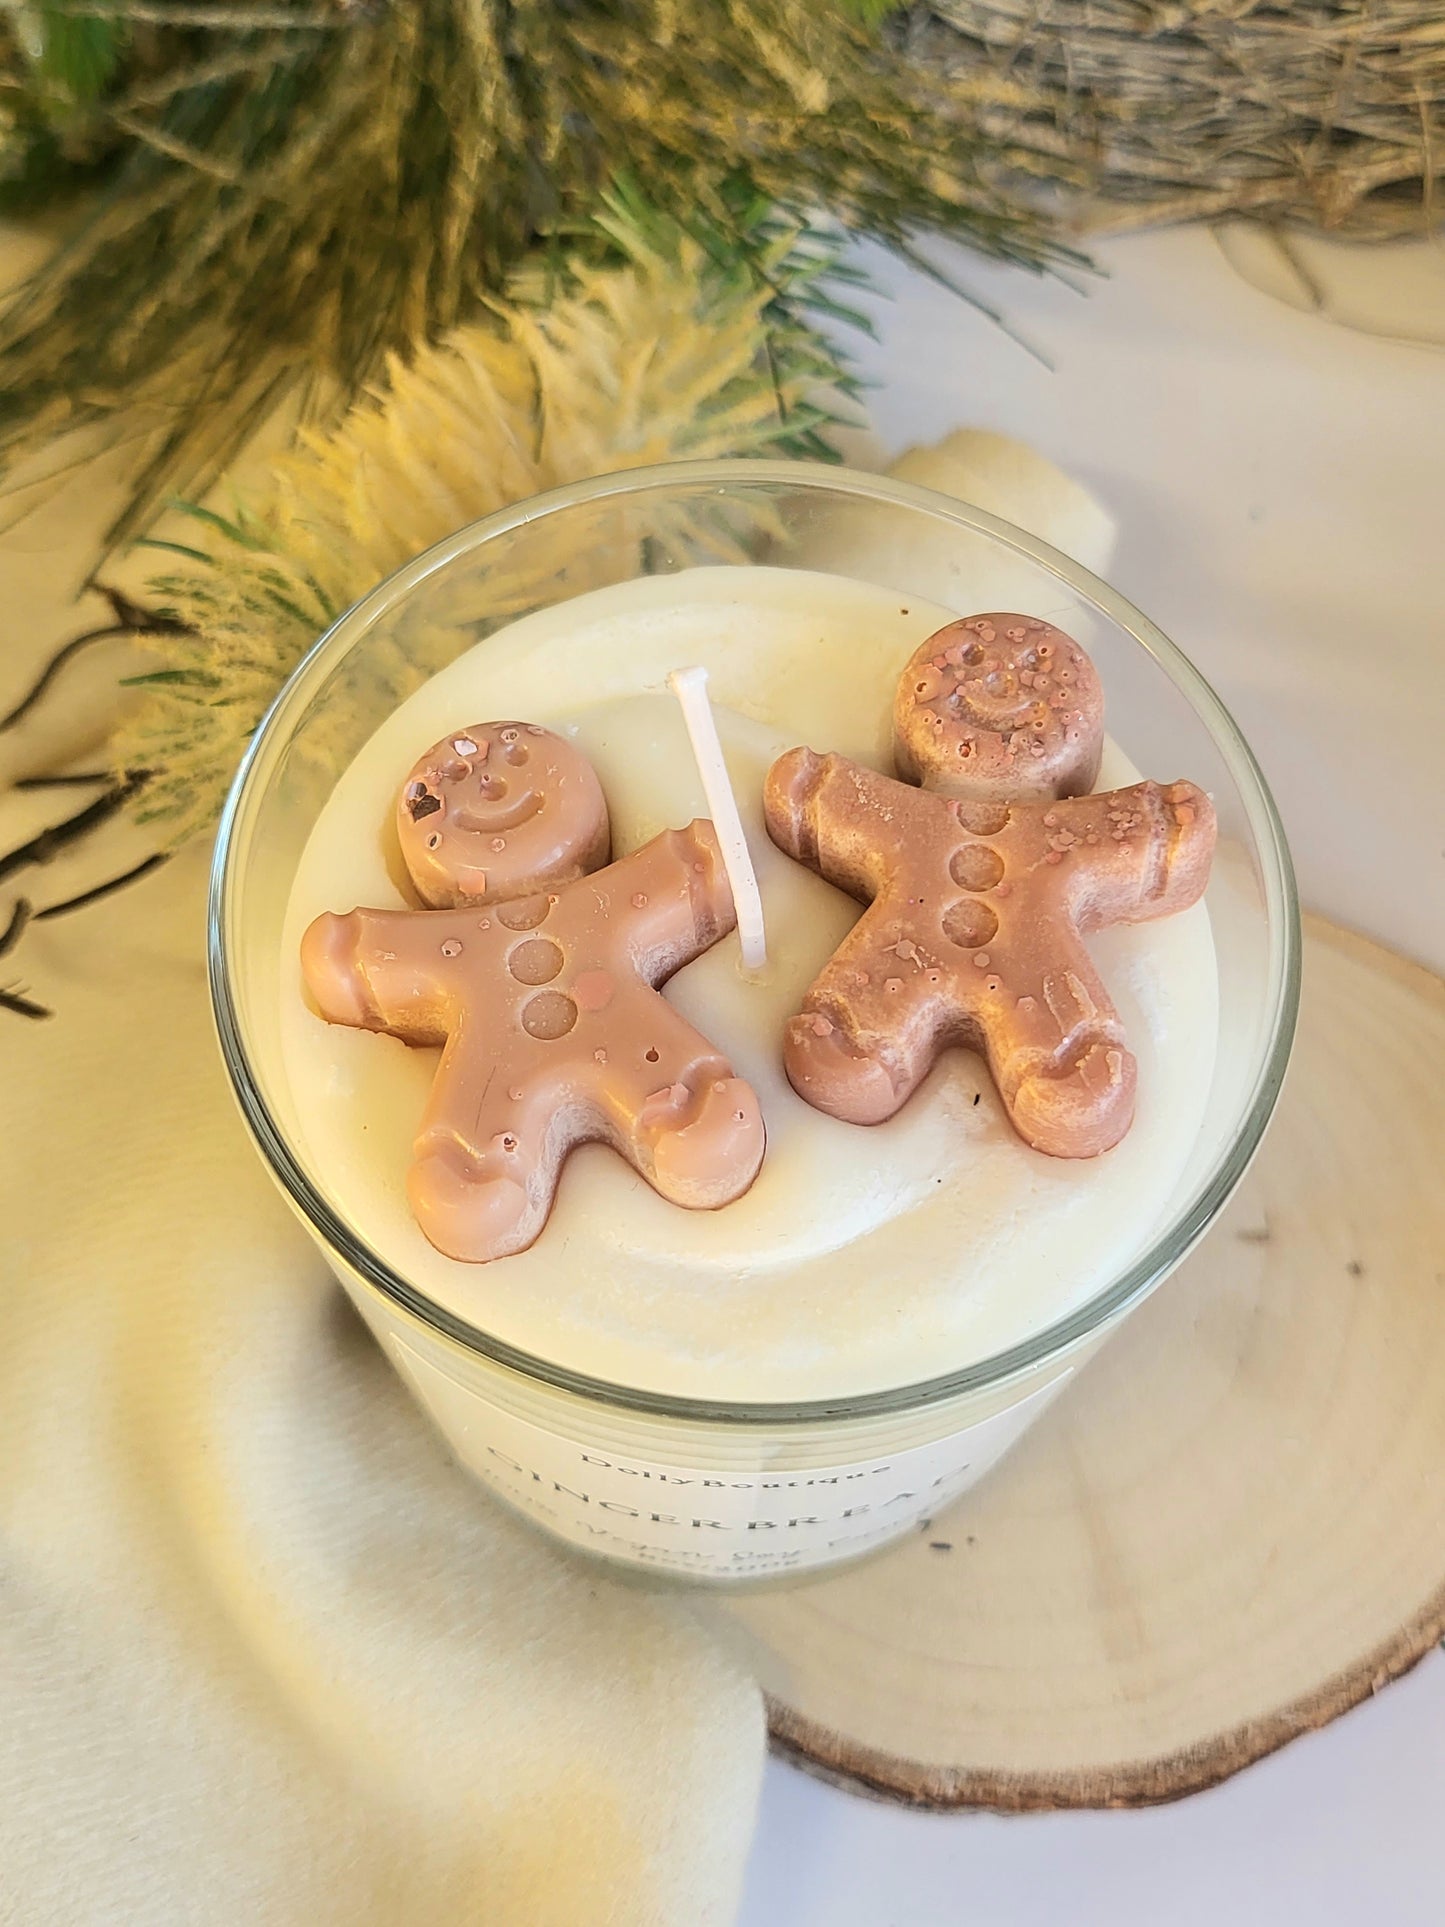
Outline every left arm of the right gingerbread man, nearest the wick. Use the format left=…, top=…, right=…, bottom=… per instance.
left=763, top=750, right=921, bottom=904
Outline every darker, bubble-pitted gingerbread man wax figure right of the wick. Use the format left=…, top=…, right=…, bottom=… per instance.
left=765, top=615, right=1214, bottom=1158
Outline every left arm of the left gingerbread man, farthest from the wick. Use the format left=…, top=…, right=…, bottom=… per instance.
left=301, top=910, right=462, bottom=1044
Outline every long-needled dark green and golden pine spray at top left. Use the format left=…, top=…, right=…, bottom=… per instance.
left=0, top=0, right=1058, bottom=551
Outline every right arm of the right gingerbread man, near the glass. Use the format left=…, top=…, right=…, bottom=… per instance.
left=1042, top=782, right=1216, bottom=931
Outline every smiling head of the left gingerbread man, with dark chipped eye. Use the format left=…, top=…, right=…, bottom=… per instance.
left=397, top=723, right=609, bottom=910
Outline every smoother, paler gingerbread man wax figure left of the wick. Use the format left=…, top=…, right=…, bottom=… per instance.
left=302, top=723, right=763, bottom=1260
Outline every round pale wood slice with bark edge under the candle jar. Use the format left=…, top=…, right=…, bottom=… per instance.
left=726, top=919, right=1445, bottom=1811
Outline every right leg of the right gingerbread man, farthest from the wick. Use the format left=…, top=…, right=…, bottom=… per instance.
left=979, top=942, right=1139, bottom=1158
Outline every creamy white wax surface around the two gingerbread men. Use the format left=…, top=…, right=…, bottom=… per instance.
left=279, top=568, right=1218, bottom=1399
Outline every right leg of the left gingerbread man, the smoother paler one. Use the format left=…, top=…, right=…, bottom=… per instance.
left=599, top=990, right=765, bottom=1210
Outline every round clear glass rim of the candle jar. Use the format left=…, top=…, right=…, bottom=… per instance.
left=206, top=447, right=1302, bottom=1426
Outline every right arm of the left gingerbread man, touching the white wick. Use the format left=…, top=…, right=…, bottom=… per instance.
left=597, top=817, right=738, bottom=985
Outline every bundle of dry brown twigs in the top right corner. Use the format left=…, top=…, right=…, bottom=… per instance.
left=917, top=0, right=1445, bottom=237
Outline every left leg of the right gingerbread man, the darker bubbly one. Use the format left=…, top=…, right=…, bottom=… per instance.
left=782, top=911, right=938, bottom=1123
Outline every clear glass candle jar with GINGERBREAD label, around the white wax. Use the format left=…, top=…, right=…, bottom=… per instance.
left=210, top=462, right=1299, bottom=1586
